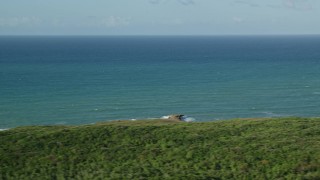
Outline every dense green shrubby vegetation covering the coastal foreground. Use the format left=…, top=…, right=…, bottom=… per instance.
left=0, top=118, right=320, bottom=179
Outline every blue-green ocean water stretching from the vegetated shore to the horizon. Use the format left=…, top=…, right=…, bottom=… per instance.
left=0, top=36, right=320, bottom=129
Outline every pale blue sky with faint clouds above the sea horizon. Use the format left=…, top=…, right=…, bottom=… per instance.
left=0, top=0, right=320, bottom=35
